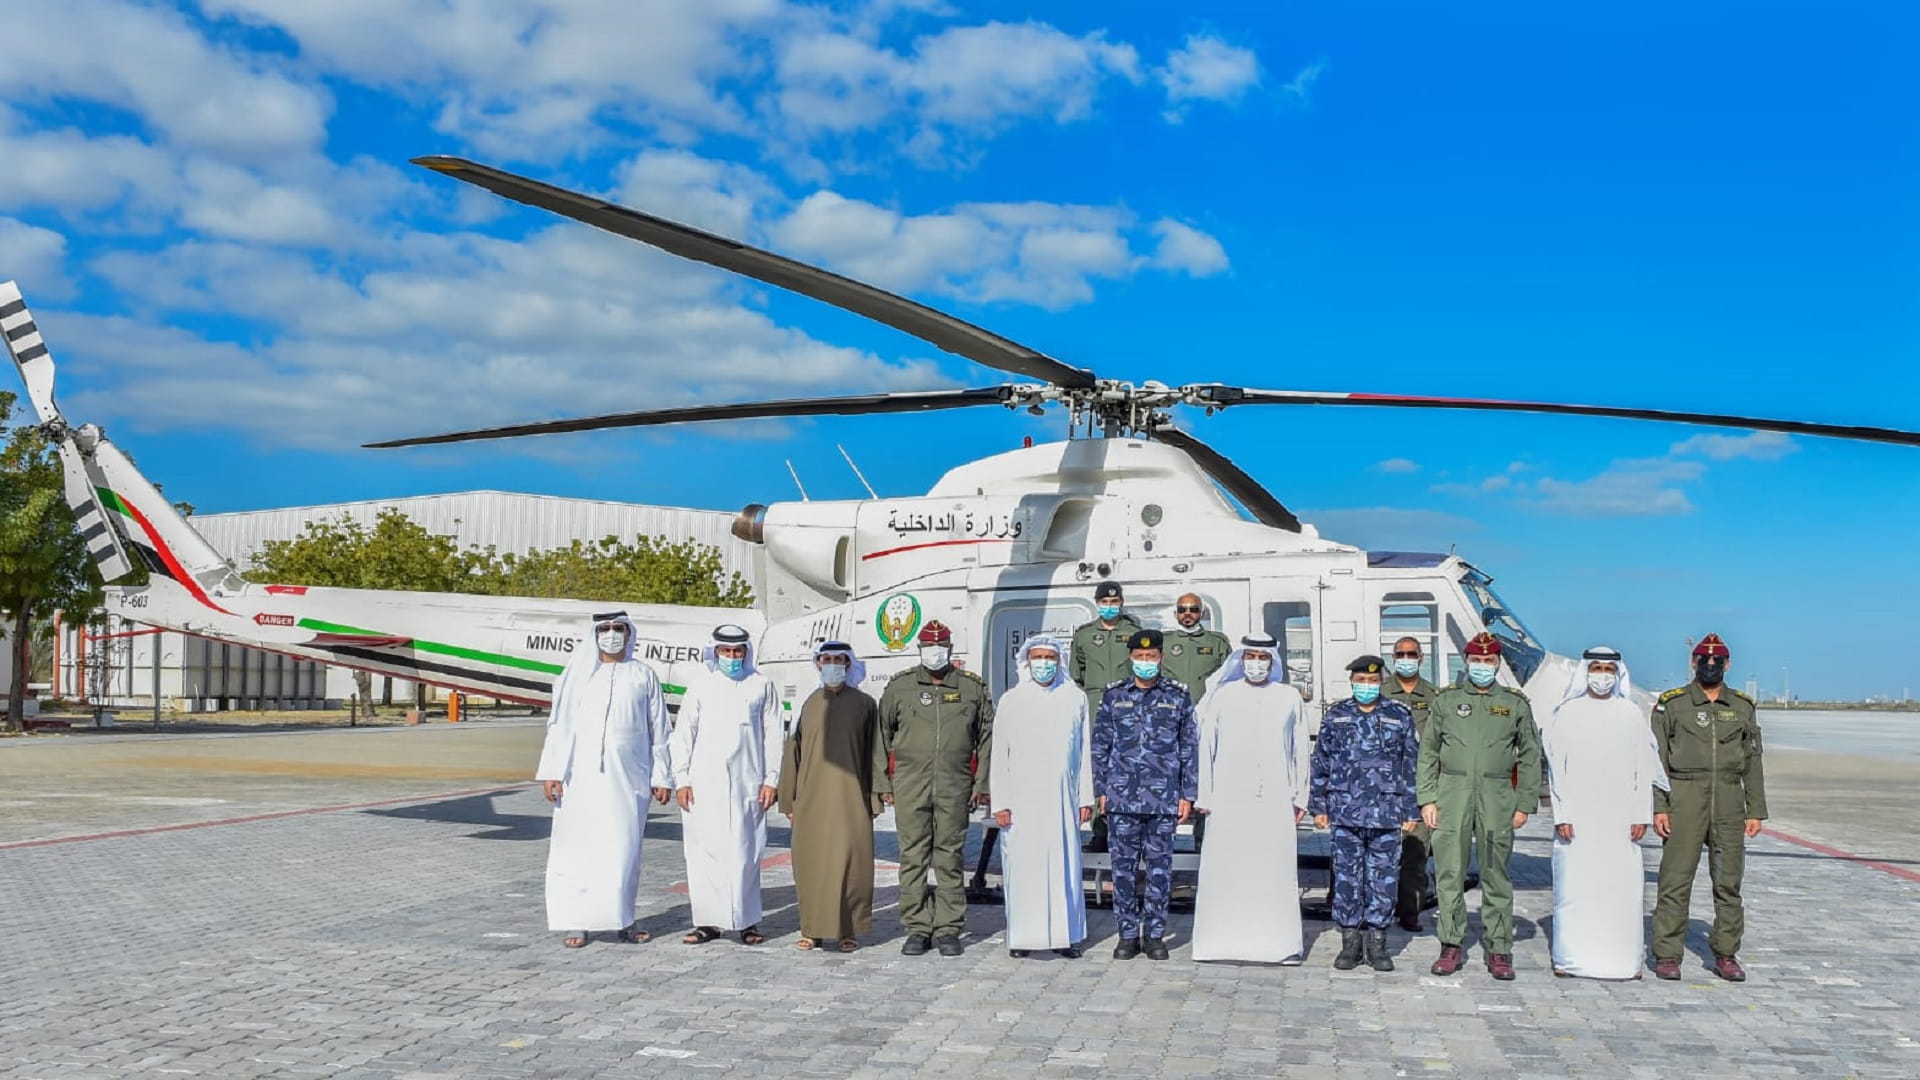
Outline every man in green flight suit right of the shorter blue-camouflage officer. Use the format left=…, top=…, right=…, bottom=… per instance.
left=1419, top=632, right=1540, bottom=982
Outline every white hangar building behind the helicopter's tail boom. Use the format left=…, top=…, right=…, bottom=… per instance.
left=52, top=492, right=758, bottom=719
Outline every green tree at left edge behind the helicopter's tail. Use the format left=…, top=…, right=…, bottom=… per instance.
left=0, top=392, right=104, bottom=730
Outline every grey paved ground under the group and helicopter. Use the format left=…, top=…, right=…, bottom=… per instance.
left=0, top=724, right=1920, bottom=1078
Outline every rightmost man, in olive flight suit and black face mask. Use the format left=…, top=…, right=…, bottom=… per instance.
left=1653, top=634, right=1766, bottom=982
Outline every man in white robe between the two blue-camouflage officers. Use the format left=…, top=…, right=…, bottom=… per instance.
left=1194, top=634, right=1311, bottom=965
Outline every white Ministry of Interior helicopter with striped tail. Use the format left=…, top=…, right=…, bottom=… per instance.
left=0, top=156, right=1920, bottom=721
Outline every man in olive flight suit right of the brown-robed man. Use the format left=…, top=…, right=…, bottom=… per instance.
left=876, top=621, right=993, bottom=957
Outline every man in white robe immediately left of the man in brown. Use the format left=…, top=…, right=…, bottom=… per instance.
left=670, top=626, right=785, bottom=945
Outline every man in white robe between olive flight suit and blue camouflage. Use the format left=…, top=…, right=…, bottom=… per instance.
left=993, top=634, right=1092, bottom=959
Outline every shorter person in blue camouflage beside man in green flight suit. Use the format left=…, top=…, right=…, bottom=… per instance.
left=1308, top=655, right=1421, bottom=970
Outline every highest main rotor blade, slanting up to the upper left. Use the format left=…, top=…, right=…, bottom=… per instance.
left=413, top=156, right=1094, bottom=388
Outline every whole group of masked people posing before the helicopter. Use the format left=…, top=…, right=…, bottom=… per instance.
left=536, top=582, right=1766, bottom=980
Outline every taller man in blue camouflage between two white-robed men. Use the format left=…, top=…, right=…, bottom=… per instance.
left=1092, top=630, right=1200, bottom=961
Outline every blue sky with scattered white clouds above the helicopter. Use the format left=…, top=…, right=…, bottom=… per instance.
left=0, top=0, right=1920, bottom=696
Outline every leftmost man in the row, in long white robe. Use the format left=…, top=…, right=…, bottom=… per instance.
left=534, top=611, right=672, bottom=949
